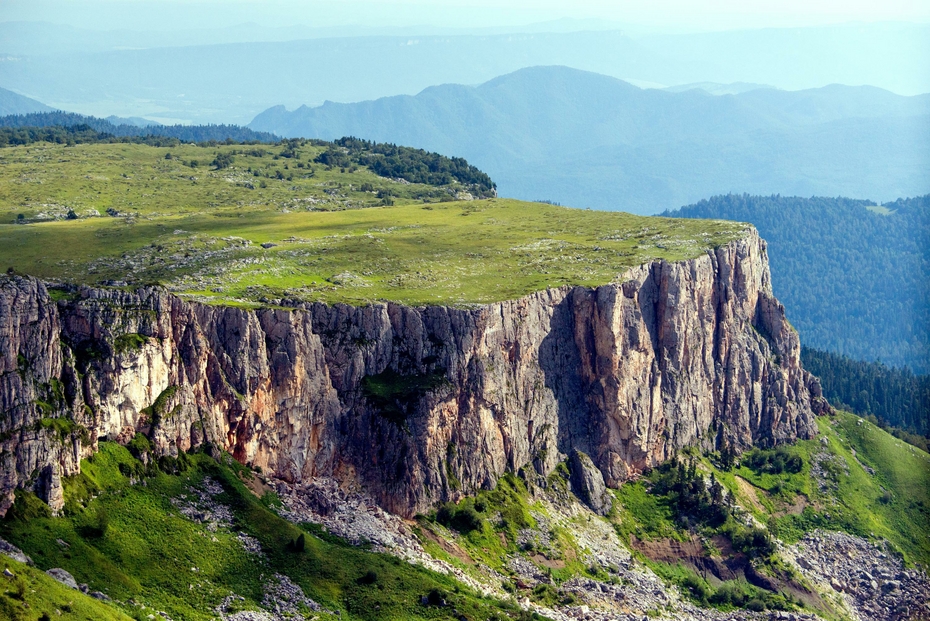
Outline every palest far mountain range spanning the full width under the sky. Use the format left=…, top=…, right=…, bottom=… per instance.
left=0, top=22, right=930, bottom=124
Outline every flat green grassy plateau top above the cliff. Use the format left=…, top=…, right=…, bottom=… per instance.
left=0, top=143, right=747, bottom=305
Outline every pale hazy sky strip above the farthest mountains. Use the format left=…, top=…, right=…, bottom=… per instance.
left=0, top=0, right=930, bottom=31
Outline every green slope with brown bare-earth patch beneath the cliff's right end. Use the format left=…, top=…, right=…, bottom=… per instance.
left=611, top=412, right=930, bottom=619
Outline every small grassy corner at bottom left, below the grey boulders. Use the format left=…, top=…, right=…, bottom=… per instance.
left=0, top=556, right=131, bottom=621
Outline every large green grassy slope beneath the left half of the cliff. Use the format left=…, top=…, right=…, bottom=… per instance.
left=0, top=442, right=548, bottom=620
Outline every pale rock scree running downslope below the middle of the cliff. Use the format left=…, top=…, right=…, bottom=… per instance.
left=274, top=472, right=817, bottom=621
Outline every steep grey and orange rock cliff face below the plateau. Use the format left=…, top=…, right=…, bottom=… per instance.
left=0, top=232, right=822, bottom=515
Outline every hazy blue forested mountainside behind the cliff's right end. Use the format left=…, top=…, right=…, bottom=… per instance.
left=666, top=195, right=930, bottom=372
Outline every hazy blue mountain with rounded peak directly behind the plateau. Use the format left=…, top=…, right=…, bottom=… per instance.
left=250, top=67, right=930, bottom=213
